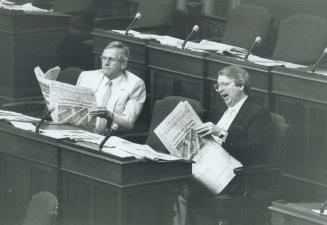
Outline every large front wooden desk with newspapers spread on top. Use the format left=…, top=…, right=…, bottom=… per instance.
left=0, top=123, right=191, bottom=225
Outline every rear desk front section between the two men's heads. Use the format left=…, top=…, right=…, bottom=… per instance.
left=147, top=42, right=206, bottom=109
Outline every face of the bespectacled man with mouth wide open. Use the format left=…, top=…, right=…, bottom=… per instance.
left=218, top=76, right=244, bottom=107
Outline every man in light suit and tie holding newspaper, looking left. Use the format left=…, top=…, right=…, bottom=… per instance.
left=76, top=41, right=146, bottom=134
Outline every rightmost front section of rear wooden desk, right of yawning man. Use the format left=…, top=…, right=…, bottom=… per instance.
left=271, top=68, right=327, bottom=201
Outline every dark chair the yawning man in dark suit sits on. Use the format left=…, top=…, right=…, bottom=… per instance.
left=190, top=113, right=289, bottom=225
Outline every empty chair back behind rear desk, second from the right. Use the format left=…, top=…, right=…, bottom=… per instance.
left=222, top=5, right=272, bottom=49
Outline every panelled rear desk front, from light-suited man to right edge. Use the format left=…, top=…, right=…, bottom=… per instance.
left=91, top=28, right=327, bottom=201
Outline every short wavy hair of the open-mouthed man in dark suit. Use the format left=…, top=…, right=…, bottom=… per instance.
left=218, top=65, right=250, bottom=94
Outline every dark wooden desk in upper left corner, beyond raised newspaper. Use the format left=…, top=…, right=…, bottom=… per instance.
left=0, top=9, right=69, bottom=104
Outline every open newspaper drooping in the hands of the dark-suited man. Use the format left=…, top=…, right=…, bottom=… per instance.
left=154, top=101, right=242, bottom=194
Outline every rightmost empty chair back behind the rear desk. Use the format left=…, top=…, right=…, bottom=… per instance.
left=273, top=14, right=327, bottom=65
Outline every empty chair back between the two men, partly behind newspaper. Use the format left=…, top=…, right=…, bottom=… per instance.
left=146, top=96, right=205, bottom=152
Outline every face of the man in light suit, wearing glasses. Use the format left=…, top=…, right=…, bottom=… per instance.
left=101, top=48, right=125, bottom=79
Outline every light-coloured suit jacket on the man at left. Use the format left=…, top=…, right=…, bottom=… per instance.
left=76, top=70, right=146, bottom=130
